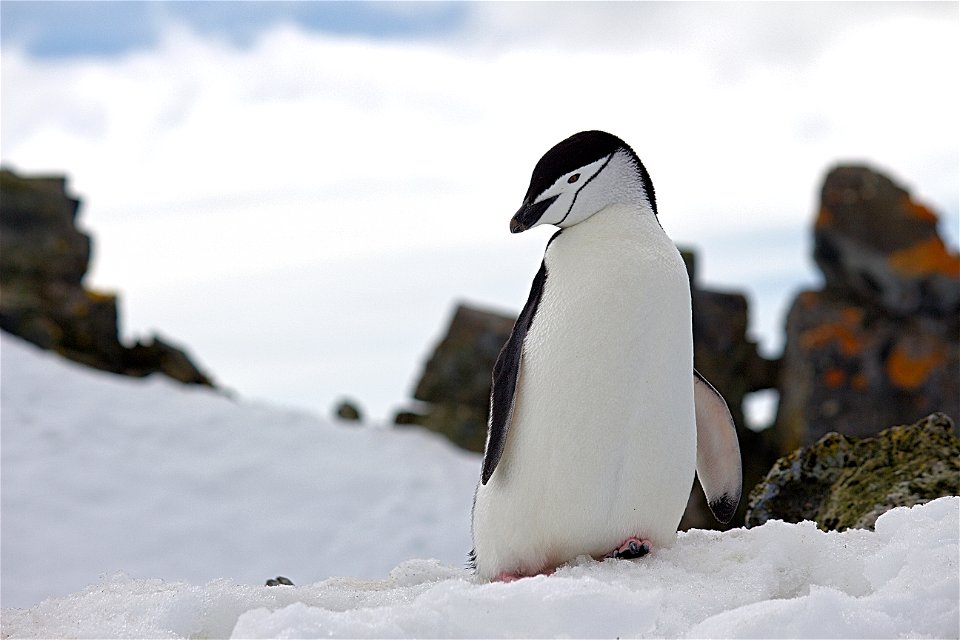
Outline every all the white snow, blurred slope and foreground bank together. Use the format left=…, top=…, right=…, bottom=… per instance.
left=0, top=335, right=960, bottom=638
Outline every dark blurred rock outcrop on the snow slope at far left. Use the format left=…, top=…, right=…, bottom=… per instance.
left=0, top=170, right=213, bottom=386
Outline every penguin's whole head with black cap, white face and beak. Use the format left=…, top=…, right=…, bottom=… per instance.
left=510, top=131, right=657, bottom=233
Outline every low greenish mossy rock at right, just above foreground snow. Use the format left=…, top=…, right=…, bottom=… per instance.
left=746, top=413, right=960, bottom=531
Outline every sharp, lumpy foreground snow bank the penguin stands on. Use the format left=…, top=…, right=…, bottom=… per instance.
left=3, top=497, right=960, bottom=638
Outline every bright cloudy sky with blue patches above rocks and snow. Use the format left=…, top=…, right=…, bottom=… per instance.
left=0, top=0, right=960, bottom=420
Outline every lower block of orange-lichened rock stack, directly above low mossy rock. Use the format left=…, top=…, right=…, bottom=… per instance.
left=777, top=291, right=960, bottom=454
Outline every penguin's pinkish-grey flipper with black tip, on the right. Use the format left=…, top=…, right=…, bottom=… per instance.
left=693, top=369, right=743, bottom=524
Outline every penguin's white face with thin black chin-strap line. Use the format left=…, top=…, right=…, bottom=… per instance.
left=512, top=151, right=646, bottom=231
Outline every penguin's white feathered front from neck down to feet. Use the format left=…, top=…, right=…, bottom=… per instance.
left=473, top=206, right=696, bottom=578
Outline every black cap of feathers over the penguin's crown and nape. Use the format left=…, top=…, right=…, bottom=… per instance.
left=524, top=131, right=657, bottom=215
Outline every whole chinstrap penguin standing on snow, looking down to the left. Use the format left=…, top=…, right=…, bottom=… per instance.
left=470, top=131, right=741, bottom=581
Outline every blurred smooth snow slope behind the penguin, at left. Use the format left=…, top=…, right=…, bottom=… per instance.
left=0, top=334, right=480, bottom=607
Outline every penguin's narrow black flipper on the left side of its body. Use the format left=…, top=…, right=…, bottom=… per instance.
left=480, top=262, right=547, bottom=484
